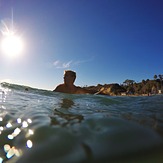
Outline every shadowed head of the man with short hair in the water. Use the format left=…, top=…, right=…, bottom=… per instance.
left=64, top=70, right=76, bottom=85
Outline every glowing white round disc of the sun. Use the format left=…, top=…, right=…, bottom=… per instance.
left=1, top=34, right=24, bottom=58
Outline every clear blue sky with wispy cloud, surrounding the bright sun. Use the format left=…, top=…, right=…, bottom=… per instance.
left=0, top=0, right=163, bottom=90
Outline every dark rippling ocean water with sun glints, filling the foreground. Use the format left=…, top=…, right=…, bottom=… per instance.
left=0, top=83, right=163, bottom=163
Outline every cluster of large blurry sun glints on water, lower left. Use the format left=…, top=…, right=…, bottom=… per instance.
left=0, top=112, right=34, bottom=163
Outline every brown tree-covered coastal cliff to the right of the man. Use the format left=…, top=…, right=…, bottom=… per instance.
left=84, top=75, right=163, bottom=95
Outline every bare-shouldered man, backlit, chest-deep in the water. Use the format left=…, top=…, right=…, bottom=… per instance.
left=53, top=70, right=91, bottom=94
